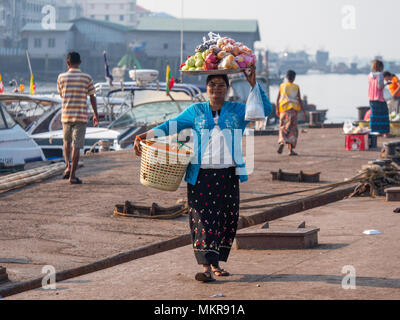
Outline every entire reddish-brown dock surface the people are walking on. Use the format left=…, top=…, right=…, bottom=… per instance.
left=0, top=129, right=400, bottom=300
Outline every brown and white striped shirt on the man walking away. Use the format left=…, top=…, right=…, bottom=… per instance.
left=57, top=69, right=95, bottom=123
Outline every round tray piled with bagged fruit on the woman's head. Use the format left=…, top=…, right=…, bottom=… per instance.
left=181, top=32, right=257, bottom=75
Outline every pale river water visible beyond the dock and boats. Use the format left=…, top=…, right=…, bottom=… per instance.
left=33, top=74, right=378, bottom=123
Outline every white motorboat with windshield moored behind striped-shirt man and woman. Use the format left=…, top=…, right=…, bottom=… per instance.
left=28, top=71, right=205, bottom=159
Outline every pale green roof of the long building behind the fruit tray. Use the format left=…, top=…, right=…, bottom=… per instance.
left=135, top=17, right=258, bottom=33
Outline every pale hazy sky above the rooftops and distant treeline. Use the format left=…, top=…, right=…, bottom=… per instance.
left=137, top=0, right=400, bottom=60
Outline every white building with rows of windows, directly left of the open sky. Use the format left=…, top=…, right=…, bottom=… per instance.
left=81, top=0, right=137, bottom=26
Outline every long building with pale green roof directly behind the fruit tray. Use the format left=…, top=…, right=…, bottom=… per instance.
left=127, top=16, right=260, bottom=81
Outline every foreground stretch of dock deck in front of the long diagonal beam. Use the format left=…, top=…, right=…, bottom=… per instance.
left=9, top=199, right=400, bottom=300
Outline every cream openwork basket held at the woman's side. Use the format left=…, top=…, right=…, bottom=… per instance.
left=140, top=141, right=193, bottom=192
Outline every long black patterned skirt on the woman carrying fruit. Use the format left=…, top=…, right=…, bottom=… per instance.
left=188, top=167, right=240, bottom=266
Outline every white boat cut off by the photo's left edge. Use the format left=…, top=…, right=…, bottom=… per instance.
left=0, top=102, right=45, bottom=171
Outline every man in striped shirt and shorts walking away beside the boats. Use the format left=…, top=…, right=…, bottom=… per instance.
left=57, top=52, right=99, bottom=184
